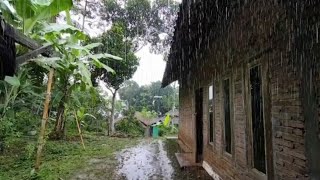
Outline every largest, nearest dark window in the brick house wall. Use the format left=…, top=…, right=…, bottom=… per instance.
left=250, top=66, right=266, bottom=173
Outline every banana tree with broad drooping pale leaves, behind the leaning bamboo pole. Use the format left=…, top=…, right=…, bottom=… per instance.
left=34, top=24, right=121, bottom=139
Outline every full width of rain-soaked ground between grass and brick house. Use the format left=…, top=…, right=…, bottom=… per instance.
left=73, top=139, right=212, bottom=180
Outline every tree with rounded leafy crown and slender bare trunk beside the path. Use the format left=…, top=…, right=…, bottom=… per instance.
left=92, top=23, right=139, bottom=133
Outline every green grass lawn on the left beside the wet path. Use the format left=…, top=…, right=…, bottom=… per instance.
left=0, top=134, right=139, bottom=180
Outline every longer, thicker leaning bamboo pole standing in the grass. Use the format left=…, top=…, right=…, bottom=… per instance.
left=35, top=68, right=54, bottom=172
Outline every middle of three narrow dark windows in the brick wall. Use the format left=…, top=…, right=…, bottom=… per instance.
left=223, top=79, right=232, bottom=154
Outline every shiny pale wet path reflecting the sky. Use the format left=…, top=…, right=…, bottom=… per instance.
left=117, top=140, right=174, bottom=180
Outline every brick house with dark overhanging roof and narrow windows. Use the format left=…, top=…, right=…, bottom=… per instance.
left=162, top=0, right=320, bottom=180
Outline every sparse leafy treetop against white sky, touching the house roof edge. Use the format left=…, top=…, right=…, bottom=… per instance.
left=104, top=0, right=179, bottom=55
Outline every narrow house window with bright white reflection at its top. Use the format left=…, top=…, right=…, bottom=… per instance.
left=208, top=85, right=214, bottom=143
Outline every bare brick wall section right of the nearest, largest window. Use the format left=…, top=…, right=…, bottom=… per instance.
left=270, top=52, right=307, bottom=179
